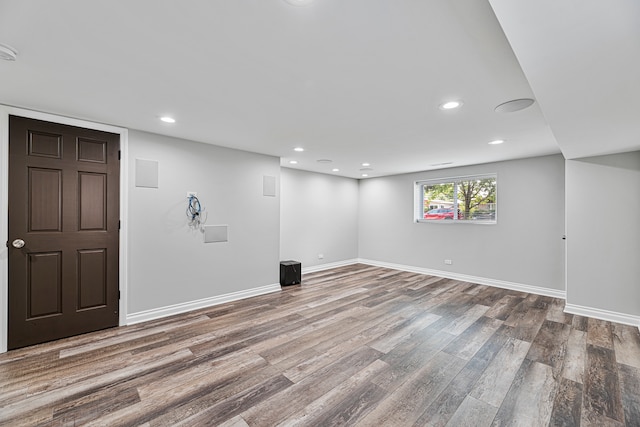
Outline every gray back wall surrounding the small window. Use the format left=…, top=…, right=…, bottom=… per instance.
left=359, top=155, right=565, bottom=291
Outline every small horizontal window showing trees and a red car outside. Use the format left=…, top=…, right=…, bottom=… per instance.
left=415, top=174, right=498, bottom=224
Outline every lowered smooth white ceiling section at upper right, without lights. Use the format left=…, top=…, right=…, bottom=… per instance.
left=489, top=0, right=640, bottom=159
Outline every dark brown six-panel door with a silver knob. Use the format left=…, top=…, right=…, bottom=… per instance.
left=8, top=116, right=120, bottom=349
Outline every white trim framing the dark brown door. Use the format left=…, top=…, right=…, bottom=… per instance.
left=0, top=104, right=129, bottom=353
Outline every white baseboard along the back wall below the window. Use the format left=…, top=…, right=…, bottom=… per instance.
left=358, top=259, right=566, bottom=299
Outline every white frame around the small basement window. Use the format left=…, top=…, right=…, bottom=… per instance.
left=413, top=173, right=498, bottom=225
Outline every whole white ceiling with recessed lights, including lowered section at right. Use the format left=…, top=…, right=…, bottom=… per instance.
left=0, top=0, right=640, bottom=178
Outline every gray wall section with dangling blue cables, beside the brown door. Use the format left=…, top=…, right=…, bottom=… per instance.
left=128, top=131, right=280, bottom=314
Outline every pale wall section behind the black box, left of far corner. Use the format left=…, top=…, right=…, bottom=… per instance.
left=280, top=168, right=358, bottom=269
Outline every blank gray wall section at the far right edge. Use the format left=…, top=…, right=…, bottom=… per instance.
left=566, top=152, right=640, bottom=316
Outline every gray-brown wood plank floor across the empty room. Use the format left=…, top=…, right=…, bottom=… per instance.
left=0, top=265, right=640, bottom=427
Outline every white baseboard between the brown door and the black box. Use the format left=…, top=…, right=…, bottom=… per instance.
left=127, top=283, right=281, bottom=325
